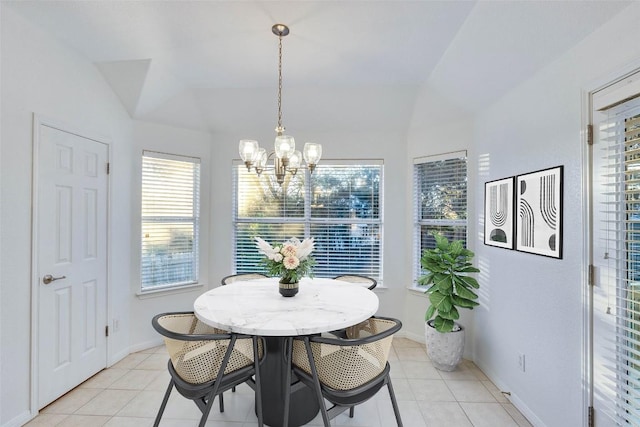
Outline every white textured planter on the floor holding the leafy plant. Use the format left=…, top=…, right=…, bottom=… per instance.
left=424, top=322, right=464, bottom=371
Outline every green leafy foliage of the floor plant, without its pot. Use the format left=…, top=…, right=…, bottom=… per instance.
left=418, top=233, right=480, bottom=333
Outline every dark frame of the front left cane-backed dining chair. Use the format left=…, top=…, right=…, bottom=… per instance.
left=151, top=312, right=265, bottom=427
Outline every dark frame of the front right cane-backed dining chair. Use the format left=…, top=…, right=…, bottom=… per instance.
left=284, top=317, right=402, bottom=427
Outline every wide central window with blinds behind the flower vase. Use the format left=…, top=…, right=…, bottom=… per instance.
left=233, top=160, right=383, bottom=280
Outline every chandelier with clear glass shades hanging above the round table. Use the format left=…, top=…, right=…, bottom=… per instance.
left=238, top=24, right=322, bottom=185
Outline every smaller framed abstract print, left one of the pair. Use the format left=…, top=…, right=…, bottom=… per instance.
left=484, top=177, right=514, bottom=249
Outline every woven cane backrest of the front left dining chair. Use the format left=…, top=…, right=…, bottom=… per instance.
left=158, top=313, right=262, bottom=384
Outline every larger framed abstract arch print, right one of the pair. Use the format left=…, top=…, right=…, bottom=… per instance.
left=516, top=166, right=563, bottom=258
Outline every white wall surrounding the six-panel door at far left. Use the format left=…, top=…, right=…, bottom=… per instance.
left=0, top=6, right=131, bottom=425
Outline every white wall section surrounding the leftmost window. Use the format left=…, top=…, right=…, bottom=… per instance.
left=126, top=122, right=214, bottom=352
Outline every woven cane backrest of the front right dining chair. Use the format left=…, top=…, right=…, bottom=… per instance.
left=292, top=318, right=397, bottom=390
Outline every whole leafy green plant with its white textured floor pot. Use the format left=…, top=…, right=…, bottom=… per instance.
left=418, top=233, right=480, bottom=371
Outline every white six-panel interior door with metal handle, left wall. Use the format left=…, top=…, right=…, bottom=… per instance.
left=34, top=124, right=108, bottom=408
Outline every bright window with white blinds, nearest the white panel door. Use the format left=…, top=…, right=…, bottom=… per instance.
left=141, top=151, right=200, bottom=292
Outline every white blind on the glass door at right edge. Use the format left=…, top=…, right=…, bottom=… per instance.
left=594, top=99, right=640, bottom=425
